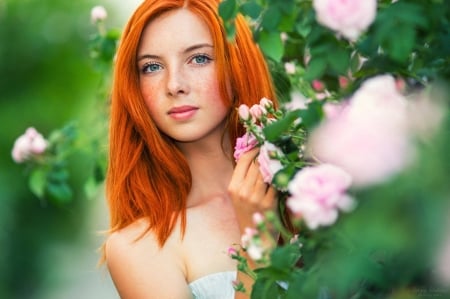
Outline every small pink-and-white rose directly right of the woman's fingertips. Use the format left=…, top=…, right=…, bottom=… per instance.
left=258, top=141, right=283, bottom=184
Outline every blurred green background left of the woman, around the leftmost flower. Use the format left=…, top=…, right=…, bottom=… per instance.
left=0, top=0, right=140, bottom=299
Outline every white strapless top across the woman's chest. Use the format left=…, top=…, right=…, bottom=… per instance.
left=189, top=271, right=237, bottom=299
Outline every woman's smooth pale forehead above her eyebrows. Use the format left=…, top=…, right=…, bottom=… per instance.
left=138, top=8, right=213, bottom=54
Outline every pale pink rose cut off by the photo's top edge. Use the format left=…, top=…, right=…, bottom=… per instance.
left=313, top=0, right=377, bottom=41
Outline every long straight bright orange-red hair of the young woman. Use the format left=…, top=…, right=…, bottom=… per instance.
left=106, top=0, right=275, bottom=246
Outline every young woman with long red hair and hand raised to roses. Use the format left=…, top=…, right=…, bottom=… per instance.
left=104, top=0, right=275, bottom=299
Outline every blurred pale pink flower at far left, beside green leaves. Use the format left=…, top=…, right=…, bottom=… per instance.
left=12, top=127, right=48, bottom=163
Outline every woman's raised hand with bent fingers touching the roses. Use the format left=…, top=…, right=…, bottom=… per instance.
left=228, top=149, right=276, bottom=231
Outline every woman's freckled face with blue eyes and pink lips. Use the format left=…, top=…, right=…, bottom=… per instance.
left=137, top=9, right=229, bottom=142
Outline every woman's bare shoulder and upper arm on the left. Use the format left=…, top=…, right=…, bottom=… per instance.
left=105, top=220, right=192, bottom=299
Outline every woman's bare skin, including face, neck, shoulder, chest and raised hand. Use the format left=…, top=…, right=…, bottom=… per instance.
left=104, top=2, right=275, bottom=299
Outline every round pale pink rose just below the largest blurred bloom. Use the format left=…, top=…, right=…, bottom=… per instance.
left=286, top=164, right=354, bottom=229
